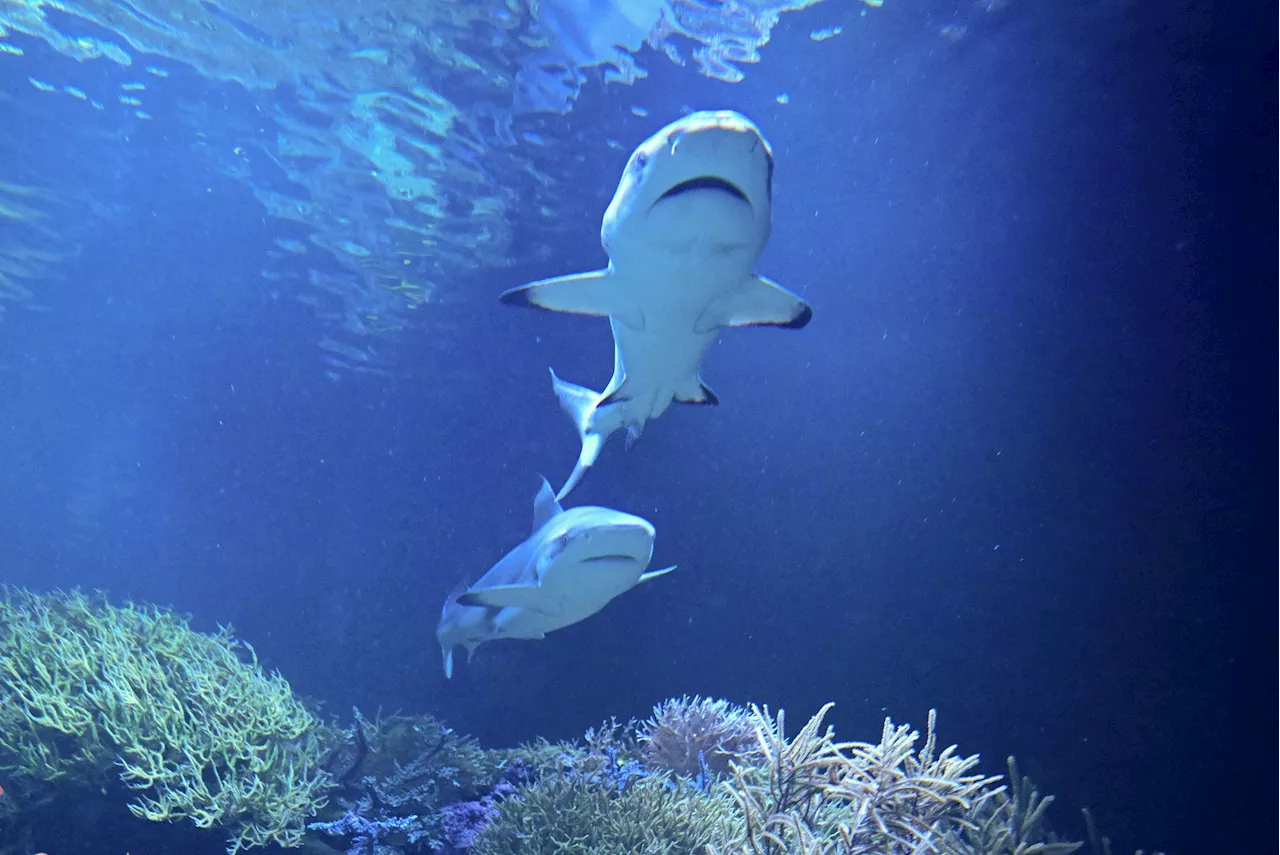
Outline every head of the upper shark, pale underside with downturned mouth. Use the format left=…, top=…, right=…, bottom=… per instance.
left=600, top=110, right=773, bottom=260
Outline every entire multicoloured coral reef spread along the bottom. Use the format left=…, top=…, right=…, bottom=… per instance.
left=0, top=589, right=1146, bottom=855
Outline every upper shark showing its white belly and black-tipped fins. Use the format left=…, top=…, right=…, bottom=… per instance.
left=500, top=110, right=813, bottom=500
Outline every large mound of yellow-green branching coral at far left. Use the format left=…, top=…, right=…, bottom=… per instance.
left=0, top=587, right=330, bottom=854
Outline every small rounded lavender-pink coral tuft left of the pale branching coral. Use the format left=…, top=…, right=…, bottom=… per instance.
left=639, top=695, right=759, bottom=778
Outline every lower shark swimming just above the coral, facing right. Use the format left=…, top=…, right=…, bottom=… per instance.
left=435, top=477, right=676, bottom=678
